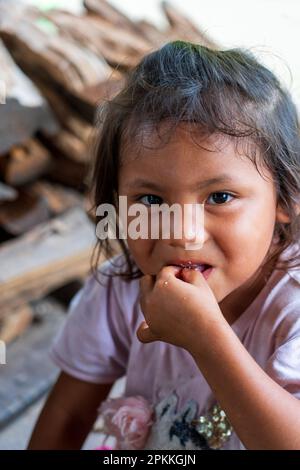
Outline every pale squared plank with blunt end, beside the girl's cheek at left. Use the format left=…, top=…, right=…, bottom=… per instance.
left=0, top=208, right=96, bottom=317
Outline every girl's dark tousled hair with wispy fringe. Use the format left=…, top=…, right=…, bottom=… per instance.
left=91, top=41, right=300, bottom=280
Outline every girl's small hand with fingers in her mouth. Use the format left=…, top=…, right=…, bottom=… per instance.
left=136, top=266, right=225, bottom=350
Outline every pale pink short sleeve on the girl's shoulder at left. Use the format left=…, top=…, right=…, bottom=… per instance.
left=50, top=262, right=132, bottom=383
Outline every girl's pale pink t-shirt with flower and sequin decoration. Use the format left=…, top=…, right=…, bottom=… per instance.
left=51, top=245, right=300, bottom=449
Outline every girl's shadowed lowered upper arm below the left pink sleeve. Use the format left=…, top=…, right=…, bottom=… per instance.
left=28, top=372, right=113, bottom=450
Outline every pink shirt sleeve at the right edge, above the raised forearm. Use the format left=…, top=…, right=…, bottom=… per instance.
left=266, top=302, right=300, bottom=399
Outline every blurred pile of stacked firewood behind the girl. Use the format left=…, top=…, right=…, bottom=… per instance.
left=0, top=0, right=214, bottom=341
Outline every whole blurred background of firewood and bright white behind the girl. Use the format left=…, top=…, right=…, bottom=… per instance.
left=0, top=0, right=300, bottom=449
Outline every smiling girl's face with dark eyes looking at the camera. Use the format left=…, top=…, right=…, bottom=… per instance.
left=119, top=126, right=283, bottom=310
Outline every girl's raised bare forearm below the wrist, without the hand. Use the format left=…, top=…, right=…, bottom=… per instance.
left=189, top=320, right=300, bottom=450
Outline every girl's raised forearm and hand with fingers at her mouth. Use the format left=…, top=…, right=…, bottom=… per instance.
left=137, top=266, right=300, bottom=450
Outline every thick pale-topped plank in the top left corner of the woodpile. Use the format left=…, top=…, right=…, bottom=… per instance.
left=0, top=5, right=111, bottom=92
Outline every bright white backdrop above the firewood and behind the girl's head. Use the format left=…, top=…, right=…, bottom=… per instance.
left=20, top=0, right=300, bottom=107
